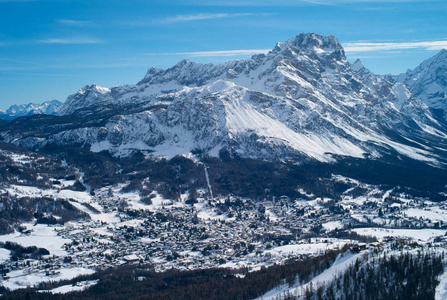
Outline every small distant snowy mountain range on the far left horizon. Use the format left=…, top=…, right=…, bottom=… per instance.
left=0, top=100, right=63, bottom=120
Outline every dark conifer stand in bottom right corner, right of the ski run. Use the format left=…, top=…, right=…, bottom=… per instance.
left=304, top=252, right=444, bottom=300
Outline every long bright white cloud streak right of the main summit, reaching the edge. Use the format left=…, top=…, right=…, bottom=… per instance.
left=343, top=40, right=447, bottom=53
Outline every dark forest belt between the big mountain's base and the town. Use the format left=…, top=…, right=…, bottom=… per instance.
left=46, top=147, right=447, bottom=204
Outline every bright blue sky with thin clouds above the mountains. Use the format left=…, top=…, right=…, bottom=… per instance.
left=0, top=0, right=447, bottom=109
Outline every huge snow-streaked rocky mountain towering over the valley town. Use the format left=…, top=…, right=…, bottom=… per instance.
left=1, top=33, right=447, bottom=164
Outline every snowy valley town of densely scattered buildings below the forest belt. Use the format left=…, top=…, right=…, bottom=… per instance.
left=2, top=177, right=447, bottom=290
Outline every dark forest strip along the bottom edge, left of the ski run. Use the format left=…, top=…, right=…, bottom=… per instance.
left=3, top=247, right=347, bottom=300
